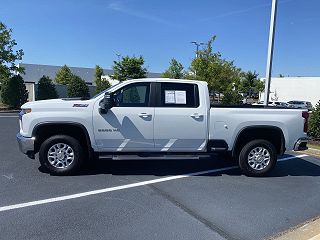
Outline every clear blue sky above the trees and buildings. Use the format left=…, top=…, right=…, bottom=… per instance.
left=0, top=0, right=320, bottom=77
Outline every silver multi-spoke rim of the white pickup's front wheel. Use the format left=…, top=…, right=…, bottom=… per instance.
left=48, top=143, right=74, bottom=168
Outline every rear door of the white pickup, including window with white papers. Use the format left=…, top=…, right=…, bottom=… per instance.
left=154, top=82, right=208, bottom=152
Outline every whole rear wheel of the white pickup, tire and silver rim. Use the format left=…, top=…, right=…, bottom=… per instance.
left=239, top=139, right=277, bottom=177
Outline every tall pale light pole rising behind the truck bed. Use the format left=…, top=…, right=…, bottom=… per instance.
left=264, top=0, right=278, bottom=106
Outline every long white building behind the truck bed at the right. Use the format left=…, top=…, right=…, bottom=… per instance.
left=260, top=77, right=320, bottom=106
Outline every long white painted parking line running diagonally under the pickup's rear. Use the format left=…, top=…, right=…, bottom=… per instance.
left=0, top=154, right=308, bottom=212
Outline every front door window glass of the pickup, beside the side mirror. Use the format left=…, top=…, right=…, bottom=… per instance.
left=113, top=83, right=150, bottom=107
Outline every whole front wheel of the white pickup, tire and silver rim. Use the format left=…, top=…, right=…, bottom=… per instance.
left=39, top=135, right=84, bottom=175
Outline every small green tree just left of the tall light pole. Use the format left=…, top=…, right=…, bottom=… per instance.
left=239, top=71, right=264, bottom=98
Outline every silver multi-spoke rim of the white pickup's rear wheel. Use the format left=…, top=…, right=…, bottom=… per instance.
left=248, top=147, right=270, bottom=171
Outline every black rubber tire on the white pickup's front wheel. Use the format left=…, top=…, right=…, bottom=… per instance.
left=39, top=135, right=85, bottom=175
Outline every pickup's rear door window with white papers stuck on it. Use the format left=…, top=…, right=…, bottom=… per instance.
left=160, top=83, right=199, bottom=108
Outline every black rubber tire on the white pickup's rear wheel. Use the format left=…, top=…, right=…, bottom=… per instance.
left=239, top=139, right=277, bottom=177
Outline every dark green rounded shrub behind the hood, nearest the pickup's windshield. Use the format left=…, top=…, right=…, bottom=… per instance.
left=67, top=75, right=90, bottom=98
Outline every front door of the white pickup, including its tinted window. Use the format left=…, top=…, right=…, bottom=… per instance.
left=93, top=82, right=154, bottom=152
